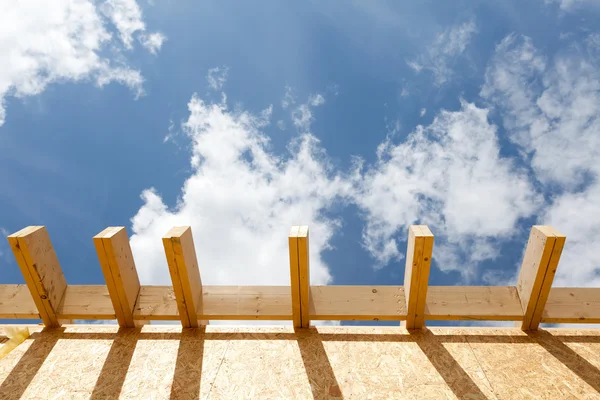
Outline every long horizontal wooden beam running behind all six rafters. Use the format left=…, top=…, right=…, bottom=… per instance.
left=0, top=285, right=600, bottom=323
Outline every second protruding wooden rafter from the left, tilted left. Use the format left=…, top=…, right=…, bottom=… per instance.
left=94, top=227, right=140, bottom=328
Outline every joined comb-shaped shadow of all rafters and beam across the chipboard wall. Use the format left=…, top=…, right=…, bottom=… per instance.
left=0, top=327, right=600, bottom=399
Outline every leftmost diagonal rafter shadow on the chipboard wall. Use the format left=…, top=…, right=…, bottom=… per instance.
left=0, top=328, right=64, bottom=400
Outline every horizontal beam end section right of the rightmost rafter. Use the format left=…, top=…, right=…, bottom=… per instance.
left=542, top=288, right=600, bottom=324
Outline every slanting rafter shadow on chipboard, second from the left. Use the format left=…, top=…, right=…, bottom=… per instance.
left=90, top=328, right=141, bottom=400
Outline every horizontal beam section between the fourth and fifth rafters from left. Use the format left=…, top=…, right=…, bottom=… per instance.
left=310, top=286, right=406, bottom=321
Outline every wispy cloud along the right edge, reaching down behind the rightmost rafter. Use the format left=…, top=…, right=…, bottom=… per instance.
left=482, top=32, right=600, bottom=286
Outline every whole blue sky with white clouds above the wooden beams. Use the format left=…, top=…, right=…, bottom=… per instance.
left=0, top=0, right=600, bottom=324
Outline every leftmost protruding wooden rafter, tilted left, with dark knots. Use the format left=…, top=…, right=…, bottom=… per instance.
left=8, top=226, right=67, bottom=327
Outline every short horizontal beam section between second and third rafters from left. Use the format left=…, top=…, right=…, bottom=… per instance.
left=133, top=285, right=180, bottom=321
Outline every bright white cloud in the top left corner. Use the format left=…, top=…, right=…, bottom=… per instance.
left=0, top=0, right=162, bottom=125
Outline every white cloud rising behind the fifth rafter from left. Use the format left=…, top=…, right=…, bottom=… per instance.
left=355, top=101, right=539, bottom=277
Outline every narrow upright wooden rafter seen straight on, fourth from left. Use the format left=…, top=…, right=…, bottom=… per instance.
left=288, top=226, right=310, bottom=328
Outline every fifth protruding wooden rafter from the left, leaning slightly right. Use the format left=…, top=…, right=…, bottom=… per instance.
left=404, top=225, right=433, bottom=329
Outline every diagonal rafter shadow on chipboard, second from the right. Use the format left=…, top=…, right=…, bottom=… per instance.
left=409, top=329, right=488, bottom=400
